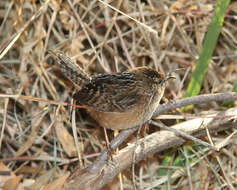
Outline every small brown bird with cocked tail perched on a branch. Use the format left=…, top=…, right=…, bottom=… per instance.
left=50, top=51, right=174, bottom=130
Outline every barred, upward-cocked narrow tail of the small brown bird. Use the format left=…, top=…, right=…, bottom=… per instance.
left=48, top=50, right=91, bottom=89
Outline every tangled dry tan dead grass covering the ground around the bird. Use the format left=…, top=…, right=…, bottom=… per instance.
left=0, top=0, right=237, bottom=190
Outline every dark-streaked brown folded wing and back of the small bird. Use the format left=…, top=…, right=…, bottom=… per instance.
left=73, top=72, right=147, bottom=112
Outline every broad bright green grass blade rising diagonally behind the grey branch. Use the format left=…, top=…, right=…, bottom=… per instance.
left=185, top=0, right=230, bottom=109
